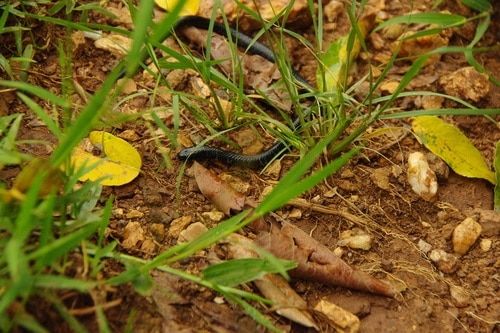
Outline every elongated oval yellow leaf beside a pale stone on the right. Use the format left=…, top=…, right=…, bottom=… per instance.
left=412, top=116, right=496, bottom=184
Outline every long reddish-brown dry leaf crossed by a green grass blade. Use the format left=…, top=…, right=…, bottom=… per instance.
left=193, top=163, right=399, bottom=297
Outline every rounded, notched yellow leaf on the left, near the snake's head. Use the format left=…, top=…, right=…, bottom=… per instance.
left=71, top=131, right=142, bottom=186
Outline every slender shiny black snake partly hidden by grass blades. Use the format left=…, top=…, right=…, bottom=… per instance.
left=175, top=16, right=311, bottom=169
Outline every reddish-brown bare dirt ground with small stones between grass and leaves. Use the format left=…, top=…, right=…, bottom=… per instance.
left=0, top=0, right=500, bottom=333
